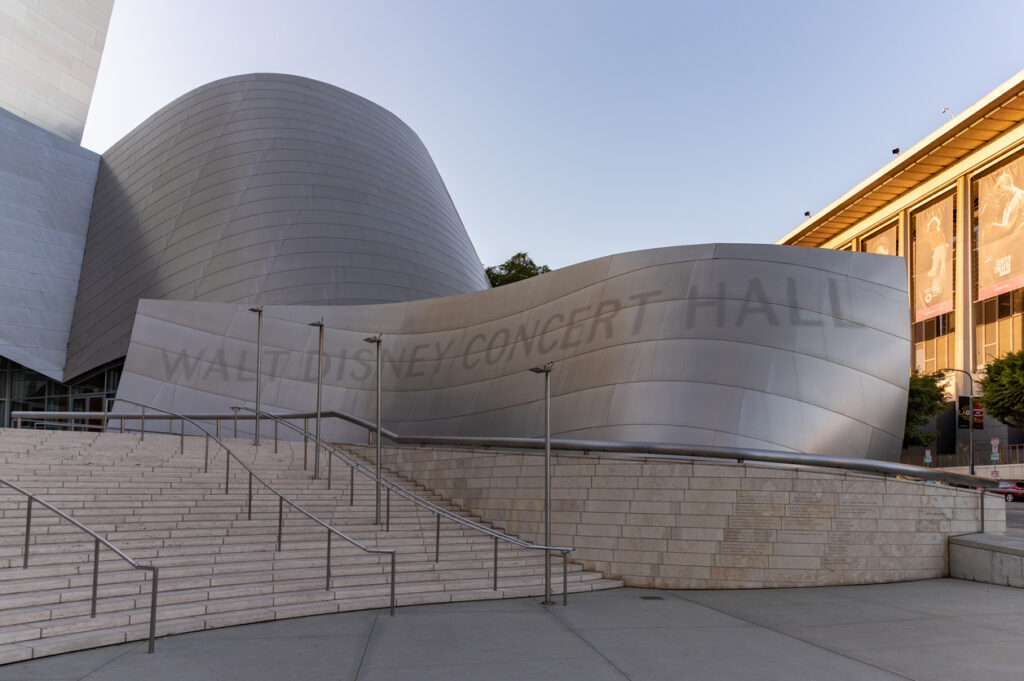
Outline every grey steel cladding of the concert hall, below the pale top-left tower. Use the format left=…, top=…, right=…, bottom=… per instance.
left=0, top=62, right=910, bottom=460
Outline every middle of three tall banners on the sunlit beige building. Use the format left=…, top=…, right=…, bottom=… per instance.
left=911, top=196, right=955, bottom=322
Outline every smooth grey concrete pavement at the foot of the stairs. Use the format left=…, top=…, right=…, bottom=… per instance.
left=0, top=580, right=1024, bottom=681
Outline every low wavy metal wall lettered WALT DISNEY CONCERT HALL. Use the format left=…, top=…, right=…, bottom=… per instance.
left=119, top=245, right=910, bottom=461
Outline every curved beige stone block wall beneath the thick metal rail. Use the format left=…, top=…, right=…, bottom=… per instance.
left=350, top=445, right=1006, bottom=589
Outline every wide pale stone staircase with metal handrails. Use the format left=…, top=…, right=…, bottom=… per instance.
left=0, top=429, right=622, bottom=664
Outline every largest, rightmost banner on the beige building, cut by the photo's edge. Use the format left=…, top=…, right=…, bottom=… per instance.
left=978, top=159, right=1024, bottom=300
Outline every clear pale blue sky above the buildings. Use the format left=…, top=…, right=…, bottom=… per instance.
left=83, top=0, right=1024, bottom=267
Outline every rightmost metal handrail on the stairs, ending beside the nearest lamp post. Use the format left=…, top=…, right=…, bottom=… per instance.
left=238, top=407, right=575, bottom=605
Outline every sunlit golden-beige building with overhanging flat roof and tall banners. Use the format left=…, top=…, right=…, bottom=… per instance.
left=777, top=66, right=1024, bottom=452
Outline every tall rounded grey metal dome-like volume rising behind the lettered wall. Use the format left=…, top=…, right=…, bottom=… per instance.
left=66, top=74, right=488, bottom=376
